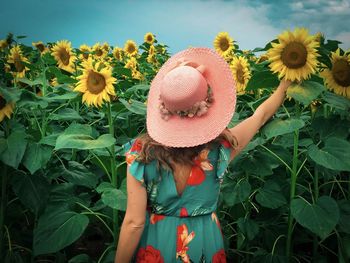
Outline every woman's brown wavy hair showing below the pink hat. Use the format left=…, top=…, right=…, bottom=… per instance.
left=137, top=128, right=238, bottom=171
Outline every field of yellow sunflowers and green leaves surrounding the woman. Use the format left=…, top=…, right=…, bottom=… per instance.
left=0, top=28, right=350, bottom=263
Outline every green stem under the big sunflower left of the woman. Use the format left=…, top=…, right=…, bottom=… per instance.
left=107, top=103, right=119, bottom=241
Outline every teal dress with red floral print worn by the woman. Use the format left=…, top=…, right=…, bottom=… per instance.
left=123, top=139, right=232, bottom=263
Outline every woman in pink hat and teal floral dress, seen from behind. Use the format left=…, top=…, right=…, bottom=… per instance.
left=115, top=48, right=290, bottom=263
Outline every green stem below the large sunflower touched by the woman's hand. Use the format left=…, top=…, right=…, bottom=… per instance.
left=286, top=101, right=300, bottom=262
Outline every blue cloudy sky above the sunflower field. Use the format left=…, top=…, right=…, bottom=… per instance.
left=0, top=0, right=350, bottom=53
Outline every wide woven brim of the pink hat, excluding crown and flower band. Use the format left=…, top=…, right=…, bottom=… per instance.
left=146, top=47, right=236, bottom=147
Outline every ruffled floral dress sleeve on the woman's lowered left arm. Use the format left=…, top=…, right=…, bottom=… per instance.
left=123, top=139, right=146, bottom=187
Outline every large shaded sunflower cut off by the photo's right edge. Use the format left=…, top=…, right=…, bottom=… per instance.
left=320, top=48, right=350, bottom=99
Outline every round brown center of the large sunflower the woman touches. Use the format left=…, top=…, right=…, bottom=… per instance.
left=281, top=42, right=307, bottom=69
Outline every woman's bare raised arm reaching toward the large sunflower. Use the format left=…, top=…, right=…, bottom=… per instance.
left=229, top=80, right=291, bottom=160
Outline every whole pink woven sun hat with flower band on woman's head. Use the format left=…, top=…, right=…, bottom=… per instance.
left=146, top=47, right=236, bottom=147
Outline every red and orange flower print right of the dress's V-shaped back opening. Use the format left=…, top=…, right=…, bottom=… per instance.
left=187, top=149, right=213, bottom=185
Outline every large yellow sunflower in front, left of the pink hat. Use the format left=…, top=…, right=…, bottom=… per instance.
left=74, top=59, right=116, bottom=107
